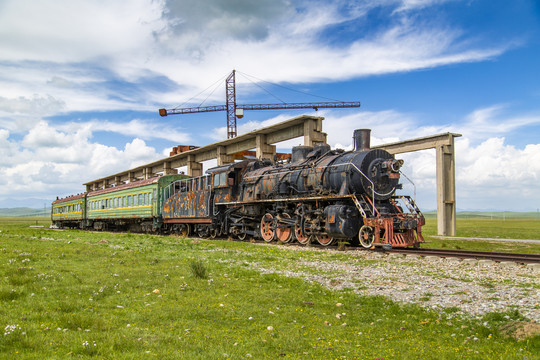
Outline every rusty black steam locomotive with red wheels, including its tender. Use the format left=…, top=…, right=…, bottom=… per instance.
left=162, top=129, right=425, bottom=248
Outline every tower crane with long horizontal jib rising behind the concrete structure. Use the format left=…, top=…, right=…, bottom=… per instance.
left=159, top=70, right=360, bottom=139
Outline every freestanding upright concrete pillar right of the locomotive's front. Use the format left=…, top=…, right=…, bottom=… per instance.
left=436, top=140, right=456, bottom=236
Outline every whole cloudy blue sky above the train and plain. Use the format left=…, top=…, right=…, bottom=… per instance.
left=0, top=0, right=540, bottom=211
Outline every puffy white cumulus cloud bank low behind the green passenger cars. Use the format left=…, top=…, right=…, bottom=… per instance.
left=0, top=120, right=162, bottom=199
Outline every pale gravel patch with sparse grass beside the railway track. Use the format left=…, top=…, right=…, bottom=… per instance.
left=237, top=244, right=540, bottom=322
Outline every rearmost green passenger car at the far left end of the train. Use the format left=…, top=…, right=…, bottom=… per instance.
left=51, top=194, right=86, bottom=228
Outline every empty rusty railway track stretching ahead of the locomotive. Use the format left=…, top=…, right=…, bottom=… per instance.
left=375, top=248, right=540, bottom=264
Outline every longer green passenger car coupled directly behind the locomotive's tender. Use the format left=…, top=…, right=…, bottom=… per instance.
left=84, top=175, right=187, bottom=232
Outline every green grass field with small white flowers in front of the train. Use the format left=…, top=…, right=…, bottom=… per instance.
left=0, top=219, right=540, bottom=359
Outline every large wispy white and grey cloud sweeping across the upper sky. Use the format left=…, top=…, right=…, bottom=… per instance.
left=0, top=0, right=511, bottom=115
